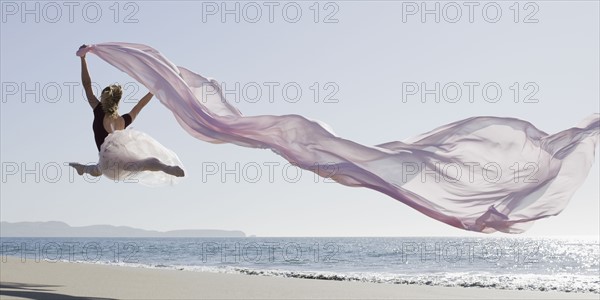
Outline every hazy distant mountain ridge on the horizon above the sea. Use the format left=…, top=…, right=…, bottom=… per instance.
left=0, top=221, right=246, bottom=237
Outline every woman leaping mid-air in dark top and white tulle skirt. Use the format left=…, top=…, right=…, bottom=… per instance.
left=69, top=45, right=184, bottom=185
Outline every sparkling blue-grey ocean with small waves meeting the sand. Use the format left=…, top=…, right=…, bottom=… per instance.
left=0, top=237, right=600, bottom=294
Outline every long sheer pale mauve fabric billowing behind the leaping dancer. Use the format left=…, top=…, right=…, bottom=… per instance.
left=77, top=43, right=600, bottom=233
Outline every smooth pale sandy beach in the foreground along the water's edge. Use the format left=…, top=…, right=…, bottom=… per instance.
left=0, top=257, right=598, bottom=299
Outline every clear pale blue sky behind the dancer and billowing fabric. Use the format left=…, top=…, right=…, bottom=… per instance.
left=0, top=1, right=600, bottom=236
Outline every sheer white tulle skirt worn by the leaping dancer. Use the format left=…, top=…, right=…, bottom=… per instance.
left=98, top=129, right=183, bottom=186
